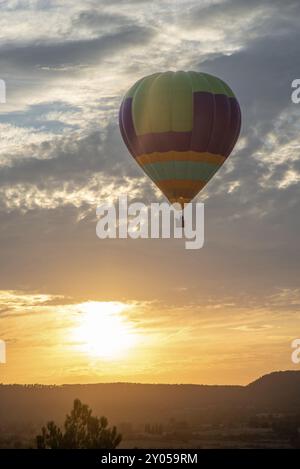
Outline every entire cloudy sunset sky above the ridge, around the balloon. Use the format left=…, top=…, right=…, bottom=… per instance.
left=0, top=0, right=300, bottom=384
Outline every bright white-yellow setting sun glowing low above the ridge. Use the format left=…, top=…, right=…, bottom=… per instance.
left=73, top=301, right=137, bottom=360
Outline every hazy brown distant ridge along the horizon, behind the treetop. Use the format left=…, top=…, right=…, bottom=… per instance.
left=0, top=371, right=300, bottom=424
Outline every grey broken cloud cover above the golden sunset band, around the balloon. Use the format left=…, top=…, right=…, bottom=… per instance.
left=0, top=0, right=300, bottom=314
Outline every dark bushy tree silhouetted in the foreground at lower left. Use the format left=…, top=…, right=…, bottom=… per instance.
left=36, top=399, right=122, bottom=449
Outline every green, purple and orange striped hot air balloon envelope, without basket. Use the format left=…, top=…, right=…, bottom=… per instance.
left=119, top=71, right=241, bottom=207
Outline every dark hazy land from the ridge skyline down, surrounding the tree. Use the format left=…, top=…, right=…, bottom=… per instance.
left=0, top=371, right=300, bottom=448
